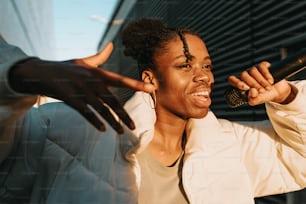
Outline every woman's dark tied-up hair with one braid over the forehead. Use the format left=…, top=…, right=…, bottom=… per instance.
left=122, top=18, right=198, bottom=73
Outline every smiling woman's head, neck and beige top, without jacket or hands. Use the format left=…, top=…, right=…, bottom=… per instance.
left=122, top=19, right=214, bottom=203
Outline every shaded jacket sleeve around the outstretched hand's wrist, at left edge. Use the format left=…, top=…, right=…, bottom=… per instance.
left=0, top=36, right=37, bottom=164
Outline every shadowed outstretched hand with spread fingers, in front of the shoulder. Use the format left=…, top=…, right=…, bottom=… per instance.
left=9, top=43, right=154, bottom=133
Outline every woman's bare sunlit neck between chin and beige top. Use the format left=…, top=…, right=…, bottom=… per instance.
left=148, top=111, right=187, bottom=166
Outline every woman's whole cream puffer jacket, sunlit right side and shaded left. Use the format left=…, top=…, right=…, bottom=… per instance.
left=0, top=39, right=306, bottom=204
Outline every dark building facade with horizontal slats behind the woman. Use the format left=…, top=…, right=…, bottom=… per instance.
left=99, top=0, right=306, bottom=204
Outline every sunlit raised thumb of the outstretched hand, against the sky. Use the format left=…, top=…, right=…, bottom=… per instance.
left=76, top=42, right=114, bottom=67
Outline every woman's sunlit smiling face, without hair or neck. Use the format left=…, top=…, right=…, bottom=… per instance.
left=154, top=34, right=214, bottom=119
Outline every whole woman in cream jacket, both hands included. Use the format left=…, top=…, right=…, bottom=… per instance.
left=0, top=19, right=306, bottom=204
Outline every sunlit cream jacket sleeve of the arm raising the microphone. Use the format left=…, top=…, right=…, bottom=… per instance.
left=234, top=81, right=306, bottom=197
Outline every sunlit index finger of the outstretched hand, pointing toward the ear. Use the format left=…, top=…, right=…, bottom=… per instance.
left=97, top=69, right=155, bottom=93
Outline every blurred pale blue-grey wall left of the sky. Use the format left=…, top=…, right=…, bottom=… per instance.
left=0, top=0, right=54, bottom=59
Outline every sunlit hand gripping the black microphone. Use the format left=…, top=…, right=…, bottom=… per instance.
left=228, top=62, right=295, bottom=106
